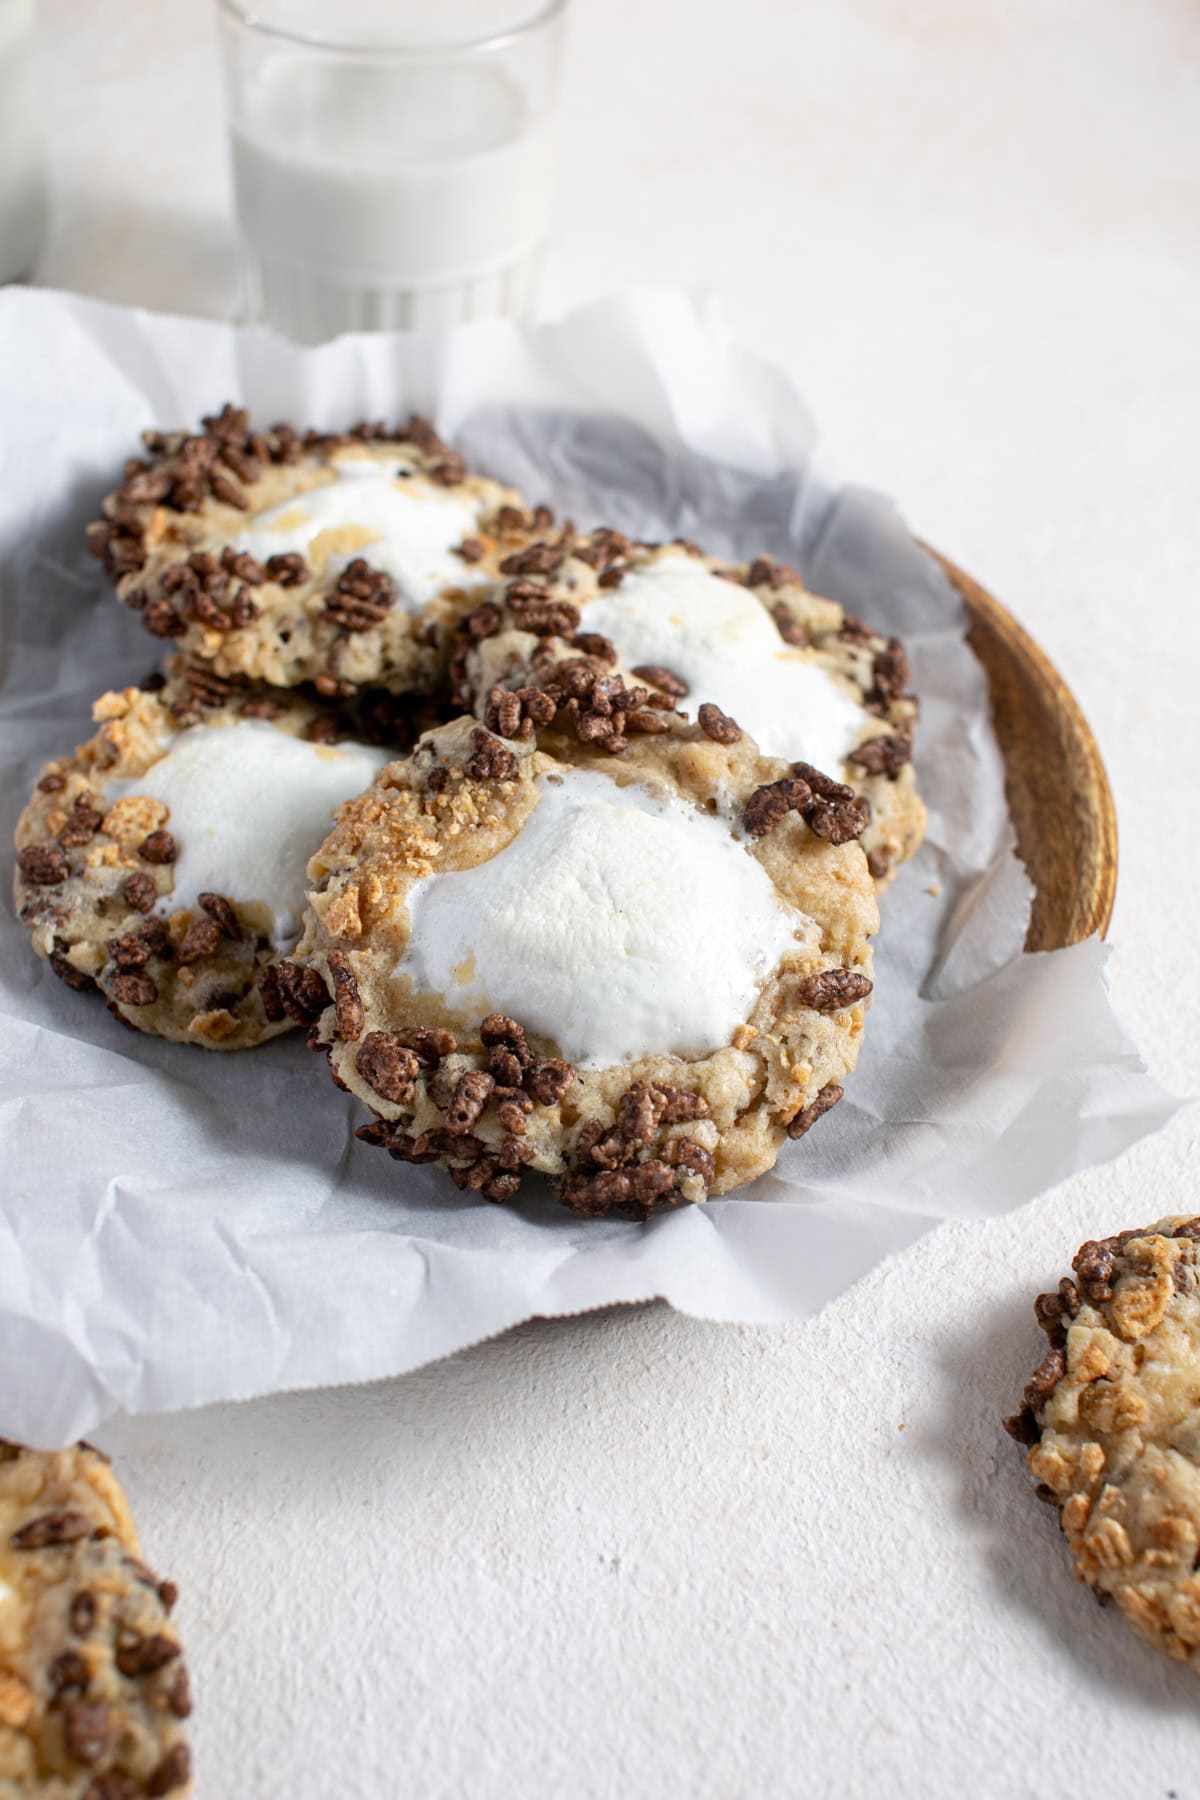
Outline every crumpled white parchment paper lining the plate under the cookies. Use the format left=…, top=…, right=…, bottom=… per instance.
left=0, top=290, right=1173, bottom=1445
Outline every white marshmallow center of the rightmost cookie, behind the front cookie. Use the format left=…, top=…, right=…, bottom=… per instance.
left=583, top=553, right=864, bottom=779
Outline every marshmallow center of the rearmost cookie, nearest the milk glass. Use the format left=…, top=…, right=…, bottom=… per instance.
left=237, top=452, right=486, bottom=612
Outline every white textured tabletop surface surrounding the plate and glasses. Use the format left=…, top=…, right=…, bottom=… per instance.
left=23, top=0, right=1200, bottom=1800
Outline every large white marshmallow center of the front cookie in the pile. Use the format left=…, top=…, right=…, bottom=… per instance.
left=398, top=769, right=808, bottom=1067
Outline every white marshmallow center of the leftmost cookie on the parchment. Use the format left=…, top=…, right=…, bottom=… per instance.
left=108, top=720, right=390, bottom=950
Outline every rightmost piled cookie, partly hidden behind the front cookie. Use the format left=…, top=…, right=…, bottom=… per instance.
left=453, top=531, right=925, bottom=884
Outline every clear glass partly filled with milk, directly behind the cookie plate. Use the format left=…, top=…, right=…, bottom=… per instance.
left=216, top=0, right=567, bottom=344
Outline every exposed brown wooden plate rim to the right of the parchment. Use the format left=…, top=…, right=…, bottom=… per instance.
left=923, top=544, right=1117, bottom=950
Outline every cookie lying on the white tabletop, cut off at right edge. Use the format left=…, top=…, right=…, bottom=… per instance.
left=1006, top=1219, right=1200, bottom=1670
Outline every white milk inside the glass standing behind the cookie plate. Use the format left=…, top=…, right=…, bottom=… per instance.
left=234, top=56, right=554, bottom=342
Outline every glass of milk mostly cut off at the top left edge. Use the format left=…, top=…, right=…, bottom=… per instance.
left=0, top=0, right=45, bottom=281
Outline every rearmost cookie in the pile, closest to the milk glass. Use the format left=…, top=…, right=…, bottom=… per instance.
left=88, top=407, right=551, bottom=697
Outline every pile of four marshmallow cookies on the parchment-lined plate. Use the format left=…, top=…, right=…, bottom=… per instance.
left=16, top=407, right=923, bottom=1217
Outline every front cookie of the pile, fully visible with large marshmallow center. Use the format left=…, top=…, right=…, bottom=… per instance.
left=297, top=706, right=878, bottom=1217
